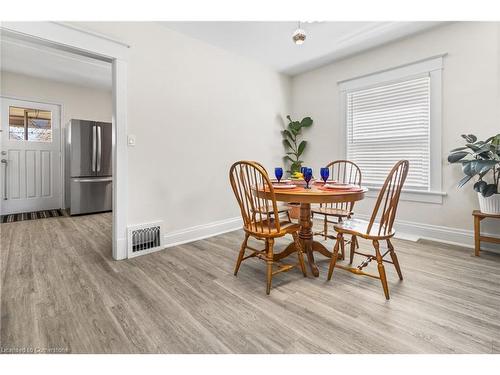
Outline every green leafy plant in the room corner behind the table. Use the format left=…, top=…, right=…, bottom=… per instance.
left=282, top=115, right=313, bottom=174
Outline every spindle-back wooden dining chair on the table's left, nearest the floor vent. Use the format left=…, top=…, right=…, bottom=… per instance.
left=229, top=161, right=307, bottom=294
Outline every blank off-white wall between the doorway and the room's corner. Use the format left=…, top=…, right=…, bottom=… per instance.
left=68, top=22, right=290, bottom=241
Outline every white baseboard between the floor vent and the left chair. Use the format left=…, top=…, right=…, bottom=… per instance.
left=163, top=217, right=242, bottom=248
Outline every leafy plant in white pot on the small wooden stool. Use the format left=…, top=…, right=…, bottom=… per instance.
left=448, top=134, right=500, bottom=215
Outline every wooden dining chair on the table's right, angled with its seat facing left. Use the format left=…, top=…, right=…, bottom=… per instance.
left=328, top=160, right=409, bottom=299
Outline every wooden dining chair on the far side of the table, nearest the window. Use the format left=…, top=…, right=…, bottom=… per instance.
left=311, top=160, right=361, bottom=259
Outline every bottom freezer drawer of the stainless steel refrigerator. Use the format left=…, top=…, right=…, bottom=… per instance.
left=70, top=177, right=113, bottom=215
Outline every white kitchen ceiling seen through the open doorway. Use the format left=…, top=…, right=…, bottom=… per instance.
left=0, top=36, right=112, bottom=90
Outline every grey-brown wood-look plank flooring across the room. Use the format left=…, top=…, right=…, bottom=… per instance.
left=0, top=214, right=500, bottom=353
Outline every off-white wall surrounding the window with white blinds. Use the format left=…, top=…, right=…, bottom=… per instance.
left=292, top=22, right=500, bottom=248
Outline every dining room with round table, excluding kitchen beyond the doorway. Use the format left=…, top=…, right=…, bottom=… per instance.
left=0, top=4, right=500, bottom=372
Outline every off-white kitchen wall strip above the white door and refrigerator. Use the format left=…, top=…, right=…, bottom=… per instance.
left=0, top=71, right=113, bottom=127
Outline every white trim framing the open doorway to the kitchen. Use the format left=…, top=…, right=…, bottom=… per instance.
left=0, top=22, right=129, bottom=260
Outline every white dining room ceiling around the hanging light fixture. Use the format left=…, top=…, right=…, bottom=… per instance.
left=161, top=22, right=440, bottom=75
